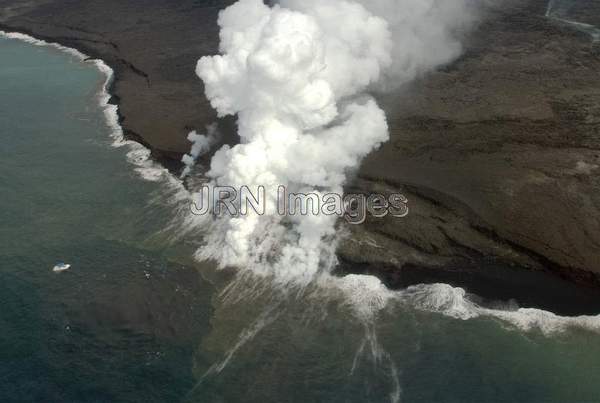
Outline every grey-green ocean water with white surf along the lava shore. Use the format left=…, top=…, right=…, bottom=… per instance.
left=0, top=34, right=600, bottom=403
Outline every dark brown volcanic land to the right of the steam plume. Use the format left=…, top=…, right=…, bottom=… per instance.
left=341, top=1, right=600, bottom=285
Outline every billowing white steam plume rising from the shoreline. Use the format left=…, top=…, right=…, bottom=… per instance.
left=196, top=0, right=476, bottom=284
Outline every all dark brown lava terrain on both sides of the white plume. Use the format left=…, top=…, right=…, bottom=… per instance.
left=0, top=0, right=600, bottom=313
